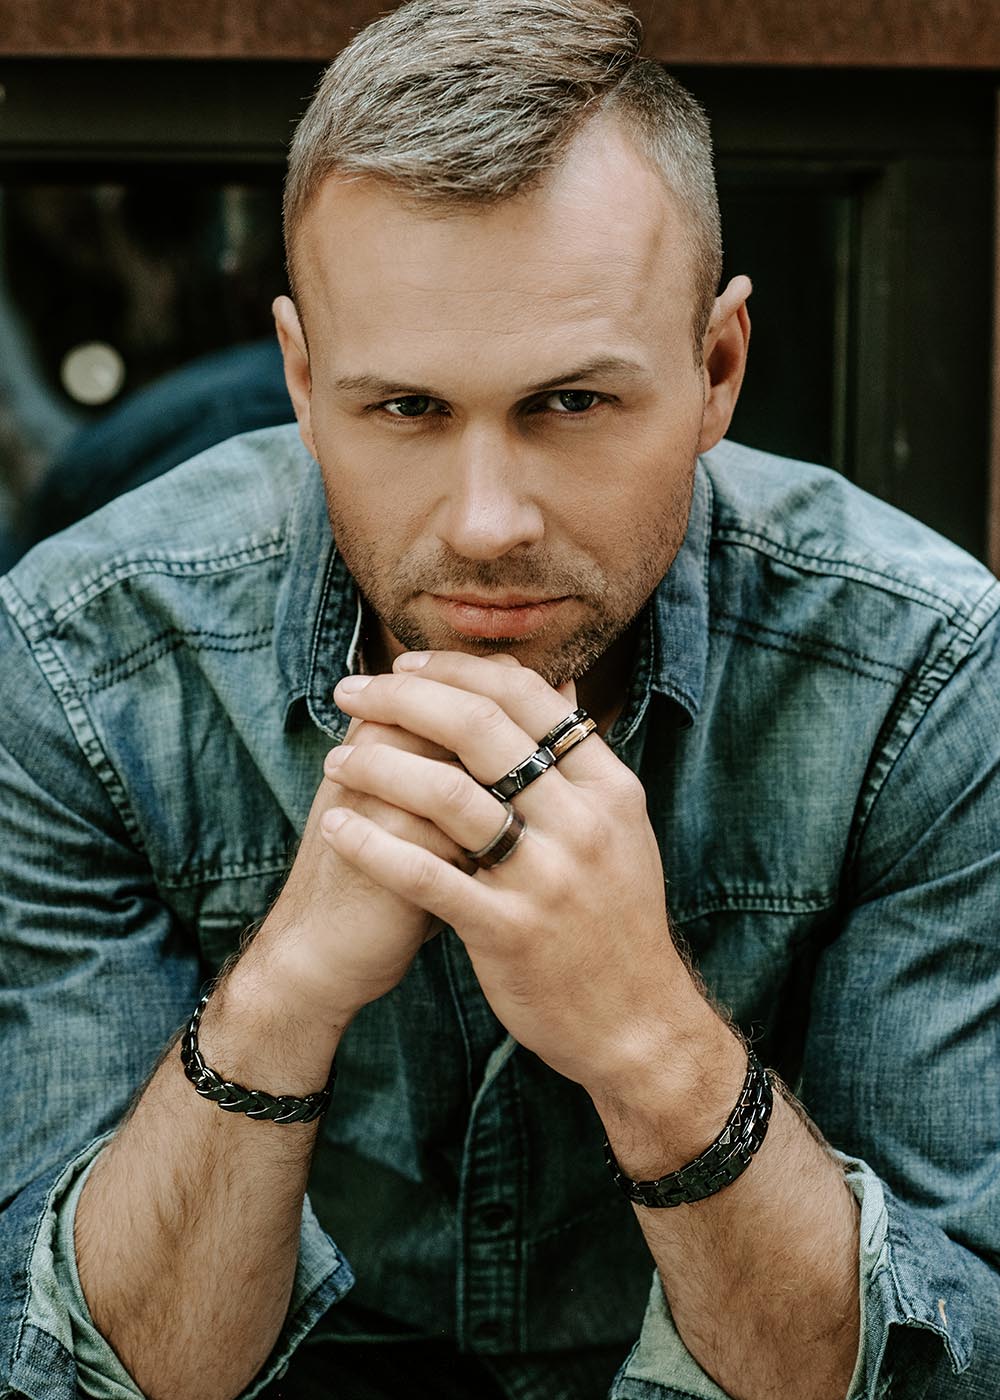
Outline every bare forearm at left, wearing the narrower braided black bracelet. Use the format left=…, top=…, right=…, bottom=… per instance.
left=76, top=955, right=342, bottom=1400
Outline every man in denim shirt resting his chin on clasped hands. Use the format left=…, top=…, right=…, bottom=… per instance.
left=1, top=0, right=1000, bottom=1400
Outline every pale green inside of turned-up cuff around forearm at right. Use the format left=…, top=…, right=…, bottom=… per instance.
left=611, top=1152, right=905, bottom=1400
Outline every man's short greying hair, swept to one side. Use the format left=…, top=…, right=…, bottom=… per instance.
left=284, top=0, right=721, bottom=357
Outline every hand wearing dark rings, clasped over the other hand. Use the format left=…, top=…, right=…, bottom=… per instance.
left=319, top=651, right=693, bottom=1092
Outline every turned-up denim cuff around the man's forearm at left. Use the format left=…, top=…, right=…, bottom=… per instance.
left=25, top=1134, right=354, bottom=1400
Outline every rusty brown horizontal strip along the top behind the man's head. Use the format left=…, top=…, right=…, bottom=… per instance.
left=0, top=0, right=1000, bottom=69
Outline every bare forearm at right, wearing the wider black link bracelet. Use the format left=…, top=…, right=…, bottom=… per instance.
left=595, top=1007, right=860, bottom=1400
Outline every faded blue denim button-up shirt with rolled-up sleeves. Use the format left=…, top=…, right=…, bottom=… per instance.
left=0, top=427, right=1000, bottom=1400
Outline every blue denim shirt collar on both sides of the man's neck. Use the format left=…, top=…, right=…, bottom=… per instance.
left=275, top=450, right=711, bottom=748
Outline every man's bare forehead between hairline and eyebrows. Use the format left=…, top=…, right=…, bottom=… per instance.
left=296, top=115, right=690, bottom=327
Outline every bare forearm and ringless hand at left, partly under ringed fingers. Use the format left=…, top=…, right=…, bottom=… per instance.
left=76, top=711, right=464, bottom=1400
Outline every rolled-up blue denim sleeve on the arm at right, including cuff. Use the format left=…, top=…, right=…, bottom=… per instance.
left=611, top=607, right=1000, bottom=1400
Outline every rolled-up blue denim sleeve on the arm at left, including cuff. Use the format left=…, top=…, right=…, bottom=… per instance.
left=0, top=596, right=353, bottom=1400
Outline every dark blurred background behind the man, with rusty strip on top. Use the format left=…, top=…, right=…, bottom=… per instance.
left=0, top=0, right=1000, bottom=570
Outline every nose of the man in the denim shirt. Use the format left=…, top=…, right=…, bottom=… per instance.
left=438, top=427, right=545, bottom=559
